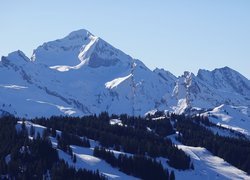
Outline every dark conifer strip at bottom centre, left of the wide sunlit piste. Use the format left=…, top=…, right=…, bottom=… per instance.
left=94, top=147, right=173, bottom=180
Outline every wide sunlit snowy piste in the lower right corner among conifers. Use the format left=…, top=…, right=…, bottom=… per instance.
left=168, top=135, right=250, bottom=180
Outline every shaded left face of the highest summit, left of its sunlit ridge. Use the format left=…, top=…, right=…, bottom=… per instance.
left=31, top=30, right=97, bottom=66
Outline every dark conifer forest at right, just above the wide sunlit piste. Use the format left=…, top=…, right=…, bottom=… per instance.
left=176, top=117, right=250, bottom=174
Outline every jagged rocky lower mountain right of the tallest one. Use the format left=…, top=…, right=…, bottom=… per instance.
left=173, top=67, right=250, bottom=135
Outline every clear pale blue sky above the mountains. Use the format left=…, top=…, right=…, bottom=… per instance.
left=0, top=0, right=250, bottom=79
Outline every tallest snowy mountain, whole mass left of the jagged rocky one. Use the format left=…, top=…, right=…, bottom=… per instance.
left=0, top=30, right=174, bottom=117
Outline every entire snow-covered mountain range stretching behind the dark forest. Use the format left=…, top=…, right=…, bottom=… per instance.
left=0, top=30, right=250, bottom=135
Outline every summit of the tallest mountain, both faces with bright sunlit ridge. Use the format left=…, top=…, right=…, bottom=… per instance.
left=31, top=30, right=132, bottom=71
